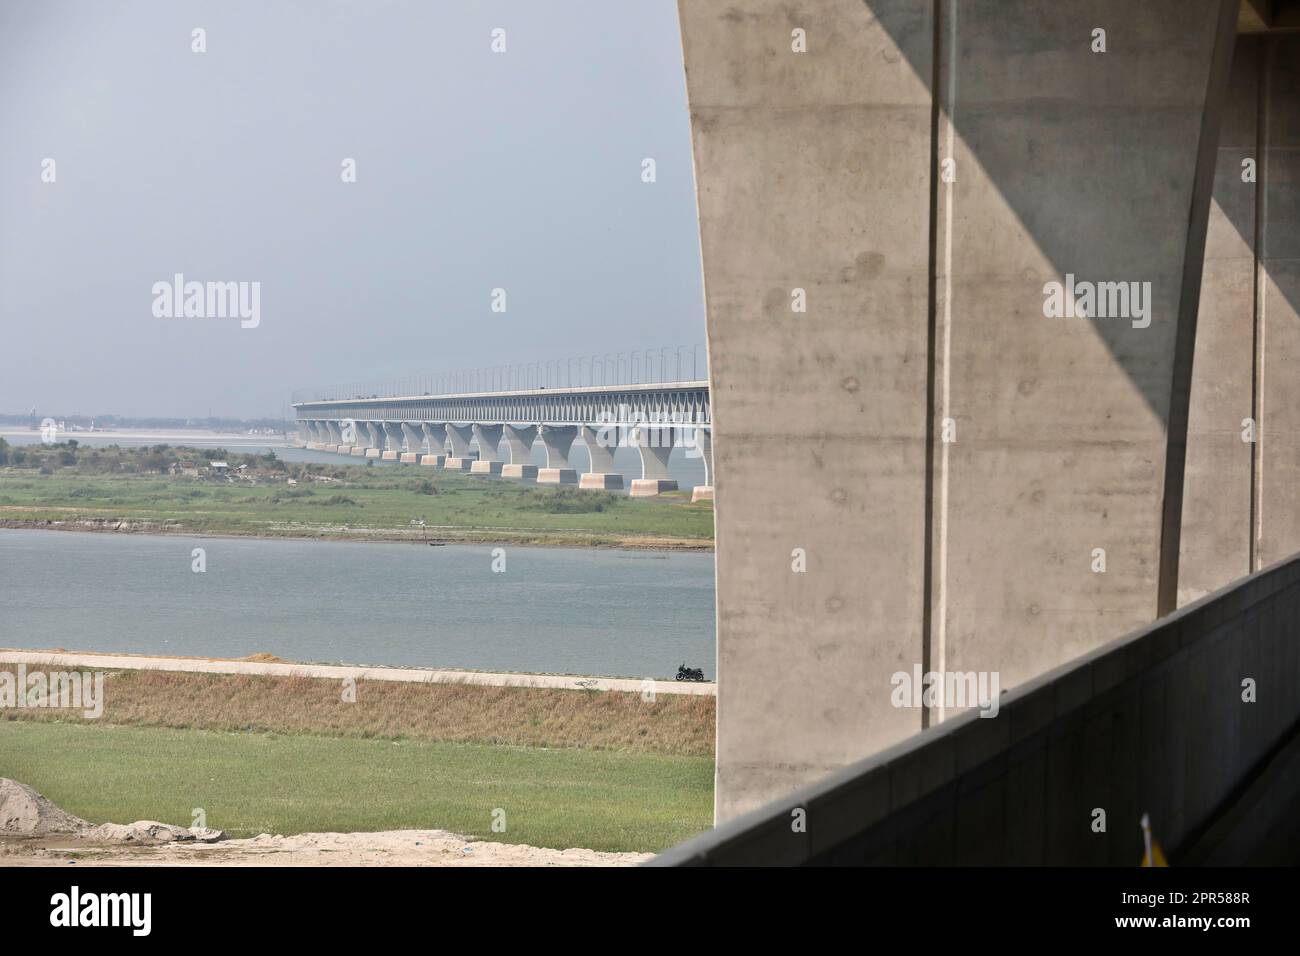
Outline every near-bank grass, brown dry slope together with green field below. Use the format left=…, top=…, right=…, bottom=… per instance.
left=0, top=671, right=714, bottom=851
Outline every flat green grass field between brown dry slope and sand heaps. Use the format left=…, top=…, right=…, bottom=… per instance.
left=0, top=721, right=714, bottom=852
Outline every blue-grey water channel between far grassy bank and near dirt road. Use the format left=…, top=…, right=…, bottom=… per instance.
left=0, top=530, right=714, bottom=679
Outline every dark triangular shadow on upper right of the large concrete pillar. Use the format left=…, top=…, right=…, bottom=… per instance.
left=863, top=0, right=1297, bottom=425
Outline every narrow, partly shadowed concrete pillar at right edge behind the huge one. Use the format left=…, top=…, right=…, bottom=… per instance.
left=1178, top=34, right=1300, bottom=605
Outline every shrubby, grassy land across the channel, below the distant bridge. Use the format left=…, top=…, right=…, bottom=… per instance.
left=0, top=445, right=712, bottom=549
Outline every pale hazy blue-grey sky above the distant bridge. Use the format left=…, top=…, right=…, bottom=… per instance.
left=0, top=0, right=705, bottom=416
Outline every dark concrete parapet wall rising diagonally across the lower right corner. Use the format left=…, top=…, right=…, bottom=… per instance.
left=651, top=555, right=1300, bottom=866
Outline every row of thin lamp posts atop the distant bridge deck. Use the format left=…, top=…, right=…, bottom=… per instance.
left=293, top=345, right=709, bottom=405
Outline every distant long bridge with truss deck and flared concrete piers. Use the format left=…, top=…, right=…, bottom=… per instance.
left=294, top=381, right=714, bottom=501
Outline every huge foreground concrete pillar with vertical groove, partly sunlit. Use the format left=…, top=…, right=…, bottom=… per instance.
left=679, top=0, right=1239, bottom=821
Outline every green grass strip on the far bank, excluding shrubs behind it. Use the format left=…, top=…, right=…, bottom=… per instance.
left=0, top=466, right=714, bottom=545
